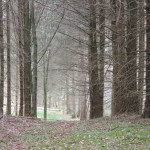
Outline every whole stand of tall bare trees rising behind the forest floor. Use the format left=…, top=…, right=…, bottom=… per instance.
left=0, top=0, right=150, bottom=120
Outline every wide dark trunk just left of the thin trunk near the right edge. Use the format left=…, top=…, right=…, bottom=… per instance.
left=126, top=0, right=139, bottom=114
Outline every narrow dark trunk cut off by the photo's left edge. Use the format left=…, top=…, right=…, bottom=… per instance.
left=0, top=0, right=4, bottom=116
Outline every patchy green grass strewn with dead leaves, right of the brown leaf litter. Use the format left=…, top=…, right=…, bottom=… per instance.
left=23, top=120, right=150, bottom=150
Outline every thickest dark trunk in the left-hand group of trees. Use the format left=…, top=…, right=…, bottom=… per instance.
left=23, top=0, right=31, bottom=116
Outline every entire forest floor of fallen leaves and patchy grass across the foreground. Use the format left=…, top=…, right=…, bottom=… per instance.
left=0, top=116, right=150, bottom=150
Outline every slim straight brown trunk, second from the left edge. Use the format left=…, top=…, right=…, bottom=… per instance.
left=6, top=0, right=11, bottom=115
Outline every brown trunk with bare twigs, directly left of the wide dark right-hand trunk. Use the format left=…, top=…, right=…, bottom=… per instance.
left=117, top=0, right=127, bottom=114
